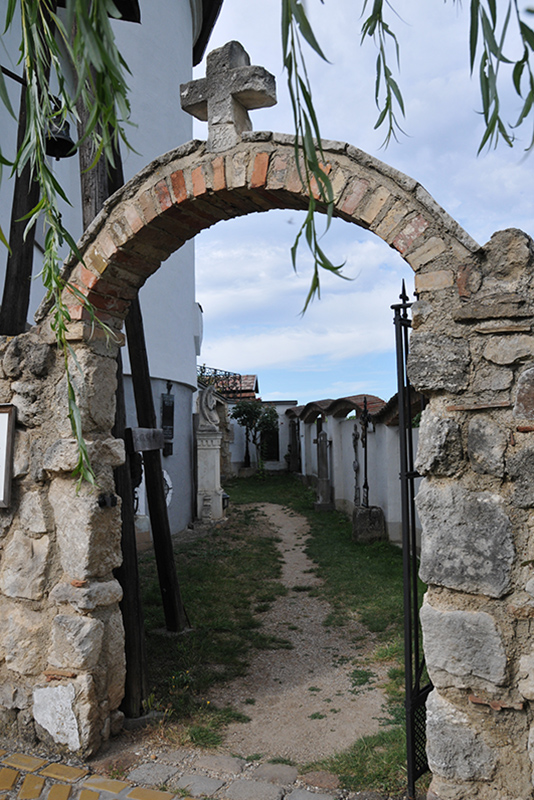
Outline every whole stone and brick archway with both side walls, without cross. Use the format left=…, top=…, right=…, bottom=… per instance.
left=0, top=132, right=534, bottom=800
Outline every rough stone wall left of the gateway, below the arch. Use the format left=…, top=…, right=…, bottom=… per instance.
left=0, top=325, right=125, bottom=754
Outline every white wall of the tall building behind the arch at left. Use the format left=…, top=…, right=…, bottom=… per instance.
left=0, top=0, right=207, bottom=530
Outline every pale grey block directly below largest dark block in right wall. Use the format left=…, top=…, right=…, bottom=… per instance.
left=420, top=602, right=506, bottom=688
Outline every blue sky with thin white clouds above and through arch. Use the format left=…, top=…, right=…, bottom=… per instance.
left=195, top=0, right=534, bottom=403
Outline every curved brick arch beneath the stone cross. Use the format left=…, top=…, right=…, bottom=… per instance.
left=50, top=133, right=479, bottom=327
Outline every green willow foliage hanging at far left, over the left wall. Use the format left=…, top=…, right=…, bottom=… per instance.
left=0, top=0, right=133, bottom=484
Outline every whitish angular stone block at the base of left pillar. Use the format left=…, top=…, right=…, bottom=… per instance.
left=33, top=683, right=80, bottom=750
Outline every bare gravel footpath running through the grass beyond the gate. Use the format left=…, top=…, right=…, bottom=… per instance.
left=209, top=503, right=385, bottom=764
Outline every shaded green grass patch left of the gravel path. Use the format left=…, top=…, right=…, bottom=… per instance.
left=139, top=508, right=291, bottom=746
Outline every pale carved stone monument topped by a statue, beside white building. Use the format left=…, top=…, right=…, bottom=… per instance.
left=196, top=386, right=224, bottom=522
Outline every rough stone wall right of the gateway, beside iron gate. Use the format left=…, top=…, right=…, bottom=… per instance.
left=409, top=230, right=534, bottom=800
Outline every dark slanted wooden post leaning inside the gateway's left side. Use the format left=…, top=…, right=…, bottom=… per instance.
left=126, top=298, right=189, bottom=632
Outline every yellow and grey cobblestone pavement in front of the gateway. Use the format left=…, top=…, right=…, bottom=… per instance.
left=0, top=748, right=398, bottom=800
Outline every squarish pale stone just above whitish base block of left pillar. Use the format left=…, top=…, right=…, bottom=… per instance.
left=48, top=614, right=104, bottom=669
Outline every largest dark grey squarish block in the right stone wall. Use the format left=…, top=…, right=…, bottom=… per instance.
left=416, top=479, right=514, bottom=597
